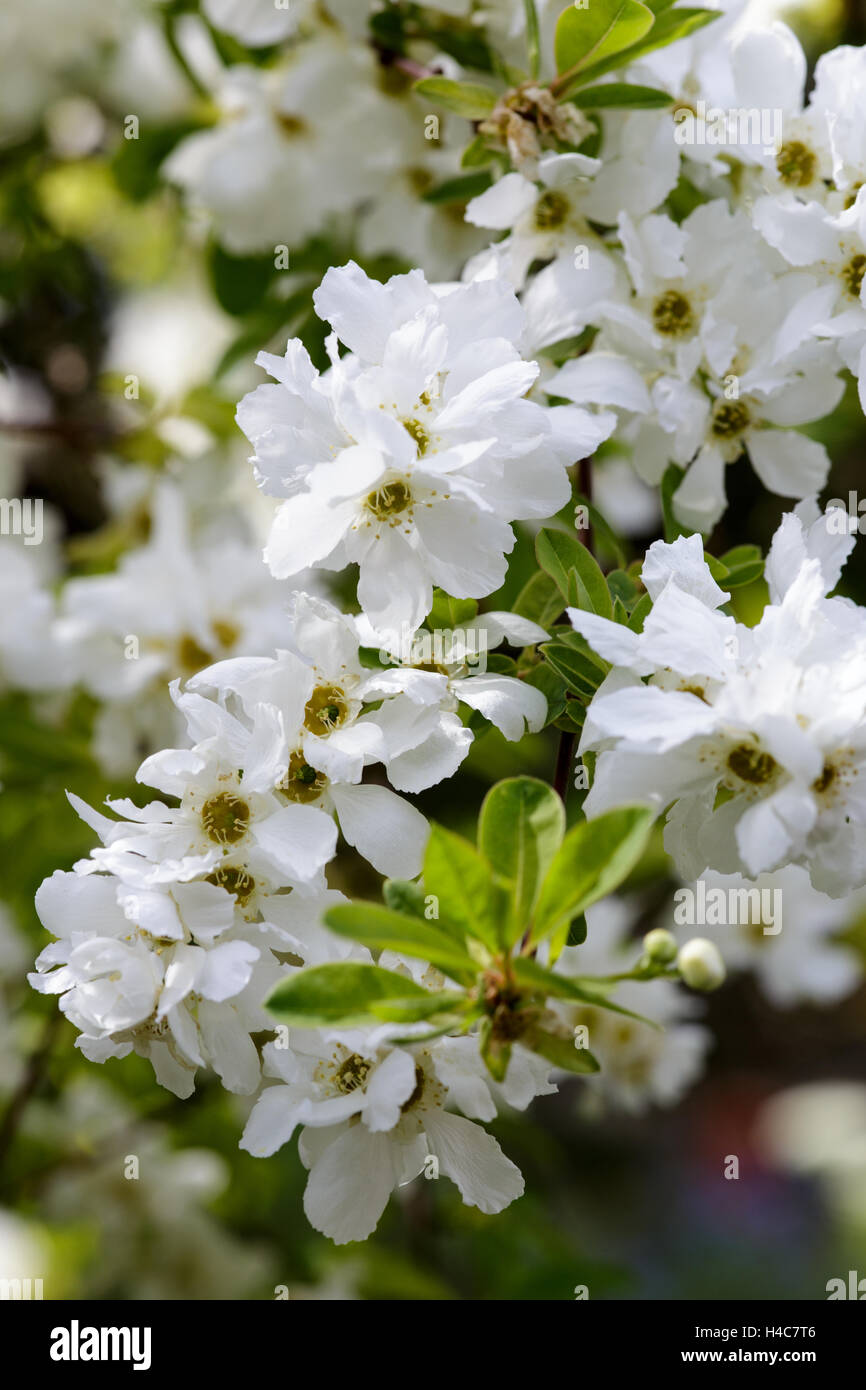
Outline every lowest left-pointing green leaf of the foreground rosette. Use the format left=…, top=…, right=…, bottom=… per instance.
left=267, top=960, right=441, bottom=1029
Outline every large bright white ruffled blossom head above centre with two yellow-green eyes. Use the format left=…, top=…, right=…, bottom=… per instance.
left=238, top=263, right=574, bottom=631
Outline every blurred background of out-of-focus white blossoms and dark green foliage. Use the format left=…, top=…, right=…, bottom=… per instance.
left=0, top=0, right=866, bottom=1300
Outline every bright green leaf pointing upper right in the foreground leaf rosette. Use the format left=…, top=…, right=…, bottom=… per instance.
left=532, top=806, right=655, bottom=941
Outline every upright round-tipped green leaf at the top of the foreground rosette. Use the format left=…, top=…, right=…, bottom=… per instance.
left=478, top=777, right=566, bottom=945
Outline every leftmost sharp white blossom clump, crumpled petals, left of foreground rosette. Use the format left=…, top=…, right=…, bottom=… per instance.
left=29, top=872, right=279, bottom=1097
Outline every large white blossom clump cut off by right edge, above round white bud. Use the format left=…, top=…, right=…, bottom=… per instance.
left=569, top=505, right=866, bottom=897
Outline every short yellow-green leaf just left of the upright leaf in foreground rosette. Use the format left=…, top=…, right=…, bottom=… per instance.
left=424, top=824, right=503, bottom=951
